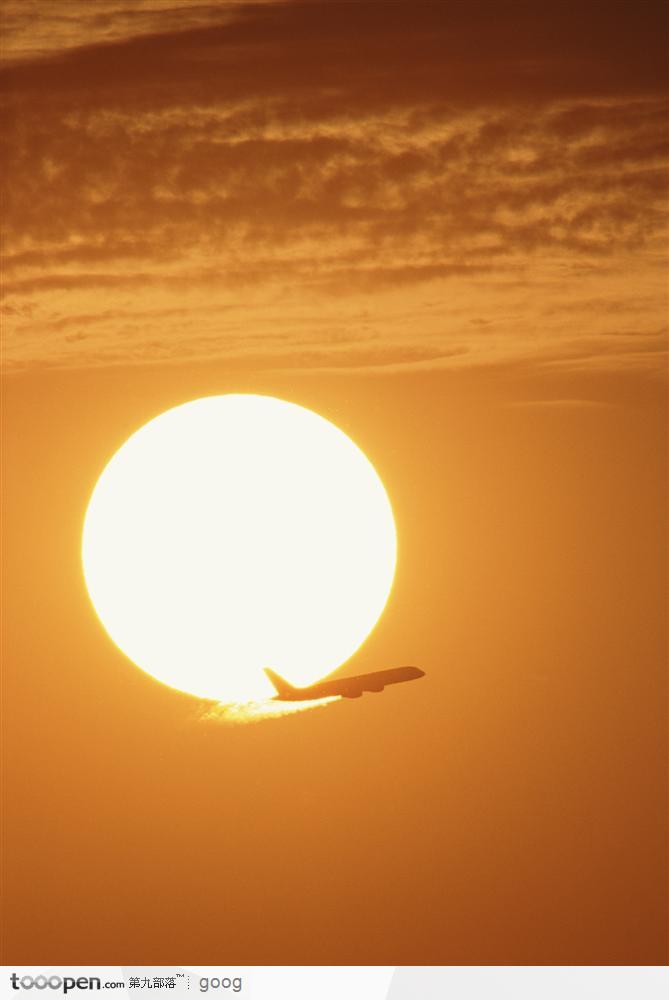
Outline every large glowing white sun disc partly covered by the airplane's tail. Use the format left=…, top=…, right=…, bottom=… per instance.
left=82, top=394, right=397, bottom=702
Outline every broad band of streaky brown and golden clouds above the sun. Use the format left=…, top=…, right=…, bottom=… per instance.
left=3, top=0, right=666, bottom=371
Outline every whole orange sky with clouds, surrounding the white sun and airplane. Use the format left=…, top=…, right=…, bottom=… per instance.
left=2, top=0, right=667, bottom=965
